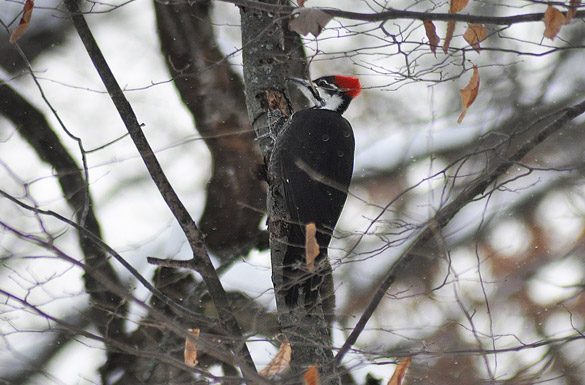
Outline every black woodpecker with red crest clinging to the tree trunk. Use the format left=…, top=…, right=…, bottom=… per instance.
left=270, top=76, right=361, bottom=310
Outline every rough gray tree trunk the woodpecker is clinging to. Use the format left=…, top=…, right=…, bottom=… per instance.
left=240, top=2, right=339, bottom=384
